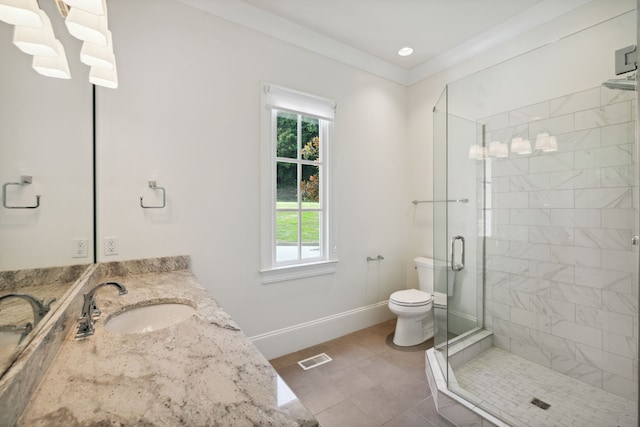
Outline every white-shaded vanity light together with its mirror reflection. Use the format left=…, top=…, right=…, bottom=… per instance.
left=0, top=0, right=118, bottom=88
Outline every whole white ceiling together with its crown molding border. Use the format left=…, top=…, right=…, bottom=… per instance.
left=179, top=0, right=592, bottom=84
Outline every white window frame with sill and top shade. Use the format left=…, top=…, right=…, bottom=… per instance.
left=260, top=83, right=338, bottom=283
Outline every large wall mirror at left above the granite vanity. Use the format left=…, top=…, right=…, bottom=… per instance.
left=0, top=2, right=94, bottom=377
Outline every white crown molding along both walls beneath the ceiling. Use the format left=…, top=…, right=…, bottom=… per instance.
left=177, top=0, right=635, bottom=86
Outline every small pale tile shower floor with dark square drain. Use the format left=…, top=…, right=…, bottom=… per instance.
left=454, top=347, right=637, bottom=427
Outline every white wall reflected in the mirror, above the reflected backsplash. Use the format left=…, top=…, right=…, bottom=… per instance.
left=0, top=2, right=93, bottom=271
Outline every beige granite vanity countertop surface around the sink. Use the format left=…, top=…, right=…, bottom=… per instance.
left=17, top=270, right=318, bottom=427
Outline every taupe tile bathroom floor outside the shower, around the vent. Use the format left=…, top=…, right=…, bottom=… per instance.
left=271, top=319, right=453, bottom=427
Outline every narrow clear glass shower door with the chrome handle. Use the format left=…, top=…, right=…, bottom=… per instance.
left=433, top=87, right=485, bottom=372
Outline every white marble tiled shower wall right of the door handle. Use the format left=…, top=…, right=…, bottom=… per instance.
left=479, top=87, right=640, bottom=397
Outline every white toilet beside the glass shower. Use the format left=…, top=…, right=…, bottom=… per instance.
left=389, top=257, right=454, bottom=347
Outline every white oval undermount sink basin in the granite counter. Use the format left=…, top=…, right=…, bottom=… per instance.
left=105, top=303, right=196, bottom=334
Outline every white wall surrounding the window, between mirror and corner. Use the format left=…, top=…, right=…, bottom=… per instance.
left=97, top=0, right=413, bottom=356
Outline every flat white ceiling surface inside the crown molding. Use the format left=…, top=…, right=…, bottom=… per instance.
left=244, top=0, right=542, bottom=70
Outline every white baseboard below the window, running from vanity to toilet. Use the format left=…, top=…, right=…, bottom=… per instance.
left=249, top=301, right=395, bottom=359
